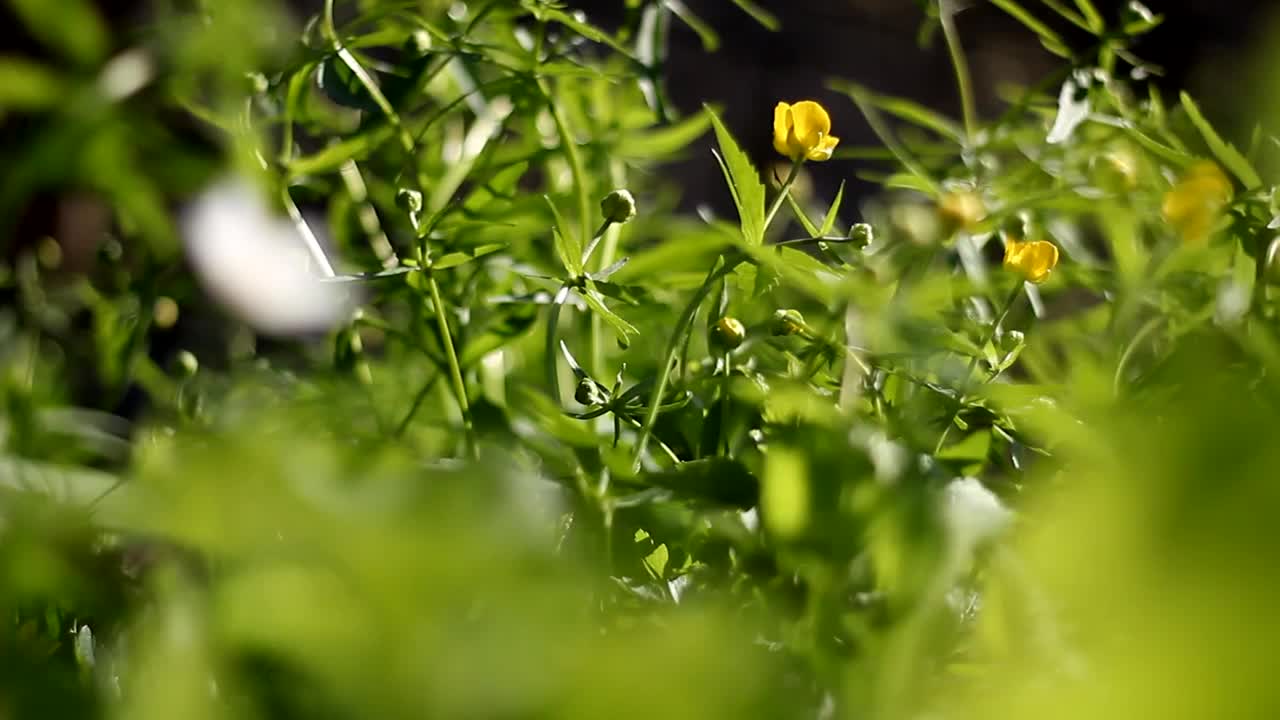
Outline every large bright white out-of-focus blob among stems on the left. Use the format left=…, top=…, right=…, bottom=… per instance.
left=182, top=179, right=352, bottom=336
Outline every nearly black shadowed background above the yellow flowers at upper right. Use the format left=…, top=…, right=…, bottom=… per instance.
left=571, top=0, right=1280, bottom=210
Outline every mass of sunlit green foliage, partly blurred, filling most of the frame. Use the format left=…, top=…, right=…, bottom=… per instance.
left=0, top=0, right=1280, bottom=719
